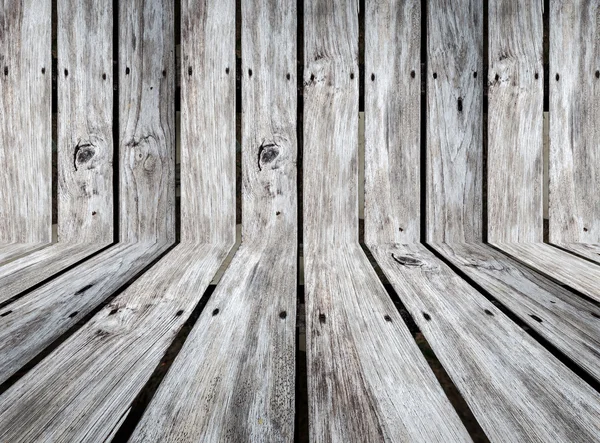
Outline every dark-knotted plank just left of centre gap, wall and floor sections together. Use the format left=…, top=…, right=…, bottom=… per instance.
left=132, top=0, right=297, bottom=442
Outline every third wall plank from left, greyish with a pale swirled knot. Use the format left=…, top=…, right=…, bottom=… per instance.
left=119, top=0, right=175, bottom=242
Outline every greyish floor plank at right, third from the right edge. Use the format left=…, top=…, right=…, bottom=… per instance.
left=432, top=244, right=600, bottom=380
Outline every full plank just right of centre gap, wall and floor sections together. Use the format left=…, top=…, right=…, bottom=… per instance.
left=303, top=0, right=470, bottom=441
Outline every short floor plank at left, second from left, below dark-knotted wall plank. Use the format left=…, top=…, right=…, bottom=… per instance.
left=0, top=243, right=109, bottom=302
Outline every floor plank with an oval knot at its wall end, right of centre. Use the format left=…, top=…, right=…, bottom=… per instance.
left=371, top=244, right=600, bottom=442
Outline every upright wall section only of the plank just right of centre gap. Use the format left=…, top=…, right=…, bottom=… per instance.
left=303, top=0, right=359, bottom=247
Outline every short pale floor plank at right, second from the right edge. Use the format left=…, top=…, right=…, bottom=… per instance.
left=494, top=243, right=600, bottom=302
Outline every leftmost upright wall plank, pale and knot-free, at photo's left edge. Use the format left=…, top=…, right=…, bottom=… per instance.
left=0, top=0, right=52, bottom=243
